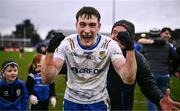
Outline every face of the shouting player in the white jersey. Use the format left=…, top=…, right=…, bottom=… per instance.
left=76, top=15, right=101, bottom=47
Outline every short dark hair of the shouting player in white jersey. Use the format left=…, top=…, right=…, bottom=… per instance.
left=76, top=6, right=101, bottom=21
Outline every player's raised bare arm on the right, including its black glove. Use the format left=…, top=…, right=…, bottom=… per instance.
left=112, top=32, right=137, bottom=84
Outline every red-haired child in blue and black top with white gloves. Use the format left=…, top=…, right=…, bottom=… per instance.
left=26, top=54, right=56, bottom=110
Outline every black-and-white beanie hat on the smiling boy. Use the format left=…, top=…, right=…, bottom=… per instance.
left=2, top=59, right=19, bottom=71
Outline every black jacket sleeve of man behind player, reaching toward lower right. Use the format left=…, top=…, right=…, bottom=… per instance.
left=135, top=51, right=164, bottom=106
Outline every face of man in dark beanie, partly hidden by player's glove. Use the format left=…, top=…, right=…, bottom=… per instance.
left=111, top=26, right=127, bottom=48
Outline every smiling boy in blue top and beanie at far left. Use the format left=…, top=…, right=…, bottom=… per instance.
left=0, top=59, right=28, bottom=111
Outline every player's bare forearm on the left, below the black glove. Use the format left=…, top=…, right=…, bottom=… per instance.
left=42, top=53, right=62, bottom=84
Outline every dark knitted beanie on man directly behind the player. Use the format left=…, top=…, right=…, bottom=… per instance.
left=111, top=20, right=135, bottom=37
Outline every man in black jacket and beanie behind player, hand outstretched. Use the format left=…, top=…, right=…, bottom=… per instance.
left=107, top=20, right=180, bottom=110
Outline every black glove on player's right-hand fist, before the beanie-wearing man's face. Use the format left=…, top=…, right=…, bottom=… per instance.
left=116, top=32, right=134, bottom=50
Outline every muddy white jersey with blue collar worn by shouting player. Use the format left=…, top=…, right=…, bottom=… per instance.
left=54, top=34, right=124, bottom=104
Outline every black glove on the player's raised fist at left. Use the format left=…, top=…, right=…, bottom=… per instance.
left=47, top=32, right=65, bottom=53
